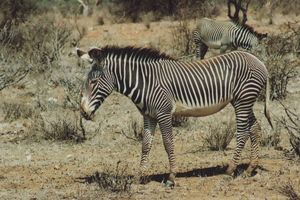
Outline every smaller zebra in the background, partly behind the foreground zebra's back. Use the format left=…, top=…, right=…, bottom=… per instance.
left=192, top=18, right=267, bottom=59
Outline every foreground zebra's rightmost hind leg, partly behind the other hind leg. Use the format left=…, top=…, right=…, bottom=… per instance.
left=246, top=112, right=261, bottom=176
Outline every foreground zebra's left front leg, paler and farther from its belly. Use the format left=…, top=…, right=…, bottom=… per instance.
left=140, top=116, right=157, bottom=183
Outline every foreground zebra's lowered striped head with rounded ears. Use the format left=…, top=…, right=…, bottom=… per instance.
left=77, top=48, right=114, bottom=120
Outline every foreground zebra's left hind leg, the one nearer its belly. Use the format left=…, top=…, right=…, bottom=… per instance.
left=226, top=108, right=251, bottom=175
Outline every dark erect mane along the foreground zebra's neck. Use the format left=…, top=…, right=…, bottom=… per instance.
left=101, top=46, right=175, bottom=60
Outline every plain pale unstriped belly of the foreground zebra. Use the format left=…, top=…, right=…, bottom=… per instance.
left=173, top=100, right=230, bottom=117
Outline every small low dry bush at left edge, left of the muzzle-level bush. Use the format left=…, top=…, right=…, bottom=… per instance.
left=2, top=102, right=34, bottom=121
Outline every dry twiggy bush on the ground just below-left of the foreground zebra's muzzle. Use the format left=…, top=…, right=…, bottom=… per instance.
left=32, top=110, right=85, bottom=143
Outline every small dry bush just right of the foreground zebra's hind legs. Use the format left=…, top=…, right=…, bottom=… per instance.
left=260, top=122, right=282, bottom=149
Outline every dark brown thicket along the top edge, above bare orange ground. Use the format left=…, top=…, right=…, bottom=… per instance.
left=106, top=0, right=226, bottom=22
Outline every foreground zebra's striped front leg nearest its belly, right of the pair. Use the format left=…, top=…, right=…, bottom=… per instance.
left=158, top=113, right=176, bottom=187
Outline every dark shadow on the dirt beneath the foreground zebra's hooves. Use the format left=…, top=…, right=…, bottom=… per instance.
left=76, top=164, right=267, bottom=184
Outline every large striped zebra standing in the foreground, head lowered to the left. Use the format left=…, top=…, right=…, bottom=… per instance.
left=77, top=46, right=272, bottom=186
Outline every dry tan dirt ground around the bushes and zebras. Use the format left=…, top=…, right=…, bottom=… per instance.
left=0, top=6, right=300, bottom=200
